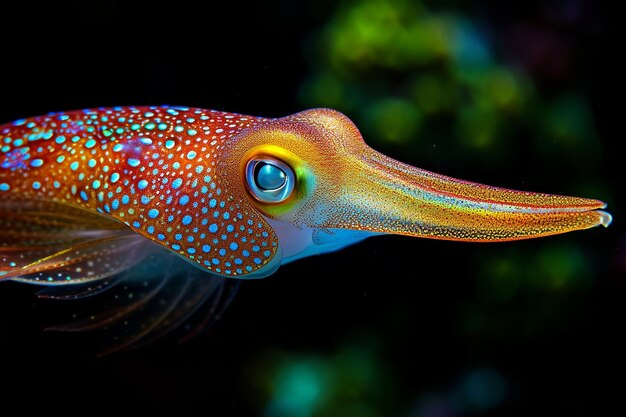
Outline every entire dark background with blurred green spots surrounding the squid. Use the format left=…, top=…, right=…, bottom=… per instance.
left=0, top=0, right=626, bottom=417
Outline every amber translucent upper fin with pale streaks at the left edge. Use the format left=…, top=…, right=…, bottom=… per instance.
left=0, top=200, right=143, bottom=285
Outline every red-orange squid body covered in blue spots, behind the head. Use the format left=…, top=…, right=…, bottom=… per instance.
left=0, top=106, right=278, bottom=276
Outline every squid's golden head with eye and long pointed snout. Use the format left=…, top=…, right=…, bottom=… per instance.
left=219, top=109, right=611, bottom=277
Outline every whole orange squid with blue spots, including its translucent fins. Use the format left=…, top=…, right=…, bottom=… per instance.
left=0, top=106, right=611, bottom=348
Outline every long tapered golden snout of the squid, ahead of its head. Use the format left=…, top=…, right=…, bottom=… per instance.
left=322, top=143, right=611, bottom=242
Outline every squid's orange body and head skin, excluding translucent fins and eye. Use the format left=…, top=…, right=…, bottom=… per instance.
left=0, top=106, right=611, bottom=278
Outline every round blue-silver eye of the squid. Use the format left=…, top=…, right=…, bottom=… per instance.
left=246, top=158, right=295, bottom=203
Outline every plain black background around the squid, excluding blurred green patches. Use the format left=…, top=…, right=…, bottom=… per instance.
left=0, top=1, right=626, bottom=416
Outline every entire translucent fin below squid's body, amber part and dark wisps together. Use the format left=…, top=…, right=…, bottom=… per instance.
left=0, top=200, right=237, bottom=353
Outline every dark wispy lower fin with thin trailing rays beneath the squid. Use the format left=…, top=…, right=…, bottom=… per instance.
left=49, top=251, right=234, bottom=354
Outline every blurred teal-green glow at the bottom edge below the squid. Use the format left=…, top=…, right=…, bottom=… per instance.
left=253, top=338, right=397, bottom=417
